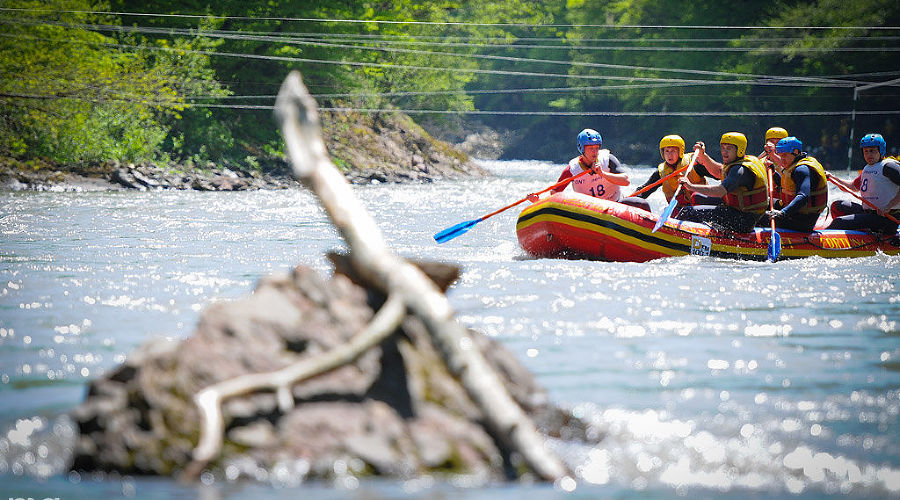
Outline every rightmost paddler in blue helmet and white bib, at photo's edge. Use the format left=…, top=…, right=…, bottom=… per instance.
left=828, top=134, right=900, bottom=234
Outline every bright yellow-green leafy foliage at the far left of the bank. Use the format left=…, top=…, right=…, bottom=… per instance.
left=0, top=0, right=176, bottom=161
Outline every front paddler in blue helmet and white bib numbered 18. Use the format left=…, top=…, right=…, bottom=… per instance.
left=528, top=128, right=650, bottom=212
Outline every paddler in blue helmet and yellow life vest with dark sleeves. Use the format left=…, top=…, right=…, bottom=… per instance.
left=766, top=136, right=828, bottom=233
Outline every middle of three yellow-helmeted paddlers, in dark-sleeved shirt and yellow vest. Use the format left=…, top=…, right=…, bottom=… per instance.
left=678, top=132, right=769, bottom=233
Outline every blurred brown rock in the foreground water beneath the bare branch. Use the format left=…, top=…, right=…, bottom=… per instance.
left=73, top=258, right=589, bottom=481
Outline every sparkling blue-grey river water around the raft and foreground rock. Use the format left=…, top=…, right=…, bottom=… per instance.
left=0, top=161, right=900, bottom=499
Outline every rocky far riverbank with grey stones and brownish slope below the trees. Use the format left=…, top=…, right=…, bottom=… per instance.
left=0, top=109, right=487, bottom=191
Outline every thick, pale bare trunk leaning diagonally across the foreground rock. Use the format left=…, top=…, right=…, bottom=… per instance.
left=275, top=72, right=568, bottom=481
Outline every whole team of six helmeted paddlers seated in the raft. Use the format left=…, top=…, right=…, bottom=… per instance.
left=528, top=127, right=900, bottom=233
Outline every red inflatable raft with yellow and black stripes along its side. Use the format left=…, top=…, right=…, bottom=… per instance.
left=516, top=192, right=900, bottom=262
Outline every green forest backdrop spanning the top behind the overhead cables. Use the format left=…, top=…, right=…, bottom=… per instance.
left=0, top=0, right=900, bottom=168
